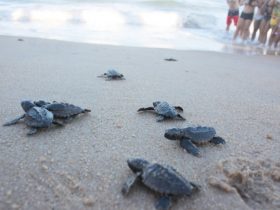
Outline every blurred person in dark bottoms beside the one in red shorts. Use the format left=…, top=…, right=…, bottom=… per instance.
left=233, top=0, right=257, bottom=41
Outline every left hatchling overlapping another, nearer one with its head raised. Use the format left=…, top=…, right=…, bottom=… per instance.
left=4, top=101, right=61, bottom=135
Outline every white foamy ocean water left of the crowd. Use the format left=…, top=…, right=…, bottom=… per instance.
left=0, top=0, right=229, bottom=51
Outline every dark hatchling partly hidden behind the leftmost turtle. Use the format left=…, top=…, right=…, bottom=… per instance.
left=34, top=100, right=91, bottom=121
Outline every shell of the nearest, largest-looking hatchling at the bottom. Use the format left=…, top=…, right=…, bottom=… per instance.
left=142, top=164, right=193, bottom=195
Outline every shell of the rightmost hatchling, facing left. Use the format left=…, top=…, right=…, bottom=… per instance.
left=184, top=126, right=216, bottom=143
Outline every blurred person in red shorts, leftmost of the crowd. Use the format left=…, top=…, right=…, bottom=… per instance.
left=226, top=0, right=240, bottom=31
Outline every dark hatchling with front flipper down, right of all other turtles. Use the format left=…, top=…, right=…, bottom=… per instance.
left=164, top=126, right=226, bottom=156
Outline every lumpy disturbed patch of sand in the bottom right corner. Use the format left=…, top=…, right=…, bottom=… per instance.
left=209, top=158, right=280, bottom=210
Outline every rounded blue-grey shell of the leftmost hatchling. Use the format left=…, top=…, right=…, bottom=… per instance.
left=24, top=106, right=53, bottom=128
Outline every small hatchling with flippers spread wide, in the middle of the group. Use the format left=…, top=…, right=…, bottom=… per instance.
left=138, top=101, right=186, bottom=122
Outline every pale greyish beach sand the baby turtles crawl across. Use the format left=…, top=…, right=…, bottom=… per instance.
left=0, top=36, right=280, bottom=210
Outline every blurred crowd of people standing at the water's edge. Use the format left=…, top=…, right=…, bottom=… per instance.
left=226, top=0, right=280, bottom=49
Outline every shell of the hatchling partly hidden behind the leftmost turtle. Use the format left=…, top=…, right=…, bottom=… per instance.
left=45, top=103, right=85, bottom=118
